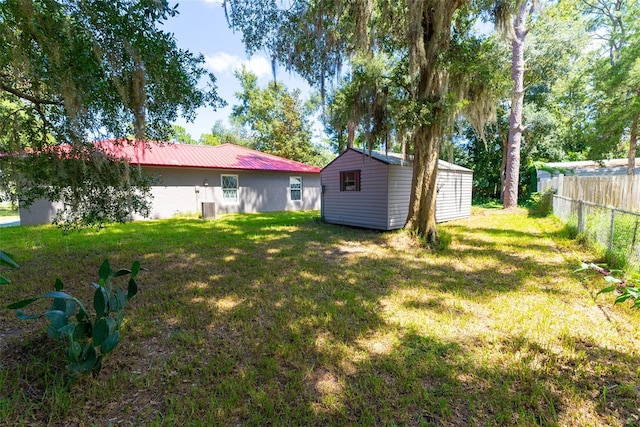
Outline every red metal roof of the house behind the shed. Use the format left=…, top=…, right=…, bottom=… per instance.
left=96, top=140, right=320, bottom=173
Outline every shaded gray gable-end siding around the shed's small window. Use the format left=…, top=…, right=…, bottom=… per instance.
left=320, top=150, right=388, bottom=230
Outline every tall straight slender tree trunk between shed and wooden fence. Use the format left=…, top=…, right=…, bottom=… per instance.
left=502, top=0, right=529, bottom=209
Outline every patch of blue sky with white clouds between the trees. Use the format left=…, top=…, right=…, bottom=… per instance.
left=163, top=0, right=317, bottom=140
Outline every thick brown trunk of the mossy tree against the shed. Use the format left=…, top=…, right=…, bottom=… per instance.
left=405, top=0, right=465, bottom=246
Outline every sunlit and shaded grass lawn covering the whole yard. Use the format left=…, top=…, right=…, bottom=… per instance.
left=0, top=209, right=640, bottom=426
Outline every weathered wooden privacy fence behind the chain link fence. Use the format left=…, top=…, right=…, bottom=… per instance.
left=544, top=175, right=640, bottom=212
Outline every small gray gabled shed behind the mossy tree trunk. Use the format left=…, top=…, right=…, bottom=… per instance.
left=320, top=148, right=473, bottom=230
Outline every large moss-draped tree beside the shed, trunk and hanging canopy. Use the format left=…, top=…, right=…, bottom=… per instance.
left=224, top=0, right=502, bottom=244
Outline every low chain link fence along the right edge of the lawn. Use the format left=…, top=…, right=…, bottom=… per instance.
left=552, top=194, right=640, bottom=270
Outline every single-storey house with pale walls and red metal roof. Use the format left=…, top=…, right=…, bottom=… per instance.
left=20, top=140, right=321, bottom=225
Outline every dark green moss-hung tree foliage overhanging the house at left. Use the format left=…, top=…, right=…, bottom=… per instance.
left=0, top=0, right=223, bottom=227
